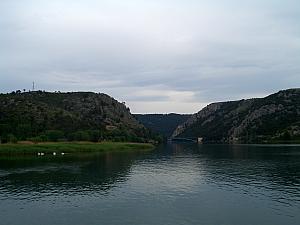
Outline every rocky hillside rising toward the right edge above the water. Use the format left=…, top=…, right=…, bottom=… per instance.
left=172, top=89, right=300, bottom=143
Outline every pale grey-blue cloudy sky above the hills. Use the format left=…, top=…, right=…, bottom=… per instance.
left=0, top=0, right=300, bottom=113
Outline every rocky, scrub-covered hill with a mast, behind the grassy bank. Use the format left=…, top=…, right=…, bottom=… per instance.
left=0, top=91, right=155, bottom=142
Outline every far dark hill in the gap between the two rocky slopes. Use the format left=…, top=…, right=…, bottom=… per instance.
left=134, top=113, right=191, bottom=137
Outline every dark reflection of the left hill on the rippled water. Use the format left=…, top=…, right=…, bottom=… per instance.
left=0, top=153, right=145, bottom=200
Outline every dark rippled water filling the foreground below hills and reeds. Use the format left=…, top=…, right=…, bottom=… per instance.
left=0, top=144, right=300, bottom=225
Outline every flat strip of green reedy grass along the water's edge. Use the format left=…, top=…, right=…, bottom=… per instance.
left=0, top=142, right=154, bottom=155
